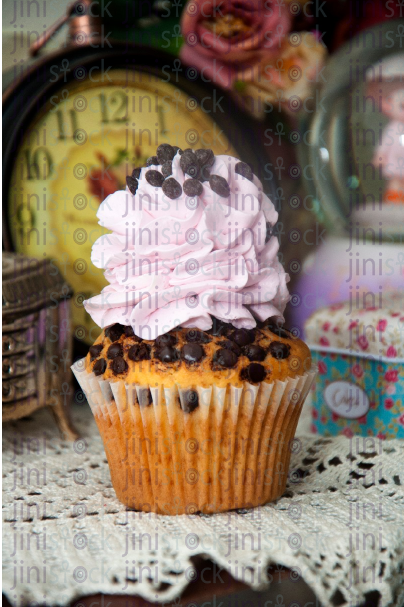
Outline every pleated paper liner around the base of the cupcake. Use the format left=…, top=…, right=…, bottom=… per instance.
left=72, top=358, right=316, bottom=515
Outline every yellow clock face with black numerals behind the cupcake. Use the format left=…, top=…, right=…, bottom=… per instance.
left=9, top=70, right=237, bottom=343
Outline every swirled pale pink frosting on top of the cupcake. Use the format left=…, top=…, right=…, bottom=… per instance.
left=84, top=153, right=289, bottom=339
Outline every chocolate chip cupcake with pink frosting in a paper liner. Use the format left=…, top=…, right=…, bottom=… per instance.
left=73, top=144, right=314, bottom=514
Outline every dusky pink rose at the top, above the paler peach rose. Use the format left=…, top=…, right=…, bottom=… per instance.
left=180, top=0, right=291, bottom=89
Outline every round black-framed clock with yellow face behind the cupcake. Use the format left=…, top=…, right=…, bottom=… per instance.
left=3, top=2, right=275, bottom=342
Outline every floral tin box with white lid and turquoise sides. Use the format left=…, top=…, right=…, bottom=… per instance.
left=305, top=294, right=404, bottom=438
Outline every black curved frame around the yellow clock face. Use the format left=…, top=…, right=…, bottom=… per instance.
left=3, top=42, right=276, bottom=251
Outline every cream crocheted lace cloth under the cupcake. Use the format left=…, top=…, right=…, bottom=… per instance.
left=3, top=403, right=404, bottom=606
